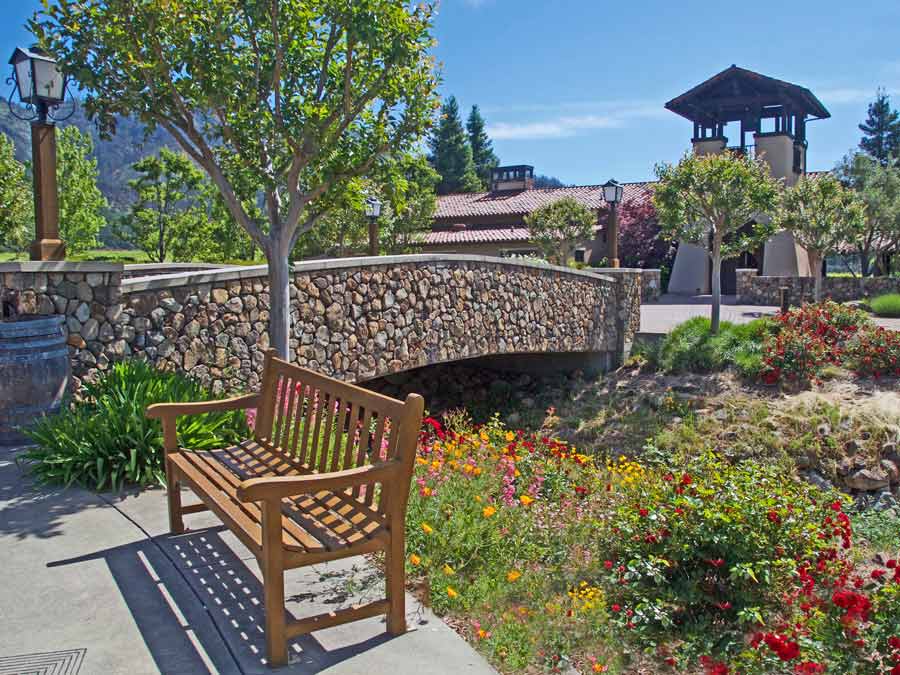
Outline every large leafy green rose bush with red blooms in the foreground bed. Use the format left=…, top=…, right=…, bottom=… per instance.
left=595, top=455, right=831, bottom=659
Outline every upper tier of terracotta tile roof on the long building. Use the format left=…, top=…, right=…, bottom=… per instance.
left=434, top=182, right=654, bottom=221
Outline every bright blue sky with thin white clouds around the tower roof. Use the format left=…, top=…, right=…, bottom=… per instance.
left=7, top=0, right=900, bottom=184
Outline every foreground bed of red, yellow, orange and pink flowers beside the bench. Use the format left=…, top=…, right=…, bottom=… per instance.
left=407, top=417, right=900, bottom=673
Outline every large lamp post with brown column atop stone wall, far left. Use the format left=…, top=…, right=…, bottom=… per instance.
left=6, top=47, right=75, bottom=260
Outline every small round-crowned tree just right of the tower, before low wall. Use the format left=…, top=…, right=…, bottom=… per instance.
left=773, top=174, right=865, bottom=302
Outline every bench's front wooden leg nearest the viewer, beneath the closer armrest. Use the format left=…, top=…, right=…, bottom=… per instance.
left=260, top=502, right=288, bottom=666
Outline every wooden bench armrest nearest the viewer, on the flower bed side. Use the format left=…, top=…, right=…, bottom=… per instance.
left=237, top=460, right=401, bottom=502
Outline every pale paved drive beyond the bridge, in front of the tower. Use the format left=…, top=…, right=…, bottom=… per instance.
left=641, top=295, right=900, bottom=333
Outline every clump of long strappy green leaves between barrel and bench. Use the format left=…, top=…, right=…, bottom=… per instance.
left=22, top=360, right=248, bottom=490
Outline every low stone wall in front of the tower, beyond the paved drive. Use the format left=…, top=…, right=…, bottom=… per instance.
left=737, top=269, right=900, bottom=305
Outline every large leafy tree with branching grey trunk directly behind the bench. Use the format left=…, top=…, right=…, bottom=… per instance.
left=37, top=0, right=436, bottom=357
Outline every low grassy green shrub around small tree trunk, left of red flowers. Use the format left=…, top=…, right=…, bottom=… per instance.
left=657, top=316, right=771, bottom=376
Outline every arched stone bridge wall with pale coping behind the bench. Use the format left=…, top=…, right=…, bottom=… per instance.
left=0, top=254, right=642, bottom=391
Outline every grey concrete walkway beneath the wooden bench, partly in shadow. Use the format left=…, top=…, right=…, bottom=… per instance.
left=0, top=447, right=494, bottom=675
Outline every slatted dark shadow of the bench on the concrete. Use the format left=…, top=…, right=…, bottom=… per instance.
left=47, top=527, right=392, bottom=675
